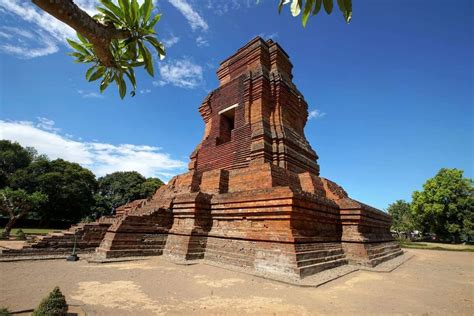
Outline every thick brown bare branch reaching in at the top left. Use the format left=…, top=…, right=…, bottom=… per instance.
left=32, top=0, right=131, bottom=67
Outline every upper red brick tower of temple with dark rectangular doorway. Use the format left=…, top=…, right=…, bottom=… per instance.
left=189, top=37, right=319, bottom=176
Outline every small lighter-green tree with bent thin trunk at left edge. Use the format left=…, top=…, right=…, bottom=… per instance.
left=0, top=187, right=48, bottom=236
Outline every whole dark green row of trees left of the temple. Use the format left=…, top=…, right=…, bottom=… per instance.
left=0, top=140, right=163, bottom=235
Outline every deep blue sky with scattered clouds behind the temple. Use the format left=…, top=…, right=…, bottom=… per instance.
left=0, top=0, right=474, bottom=209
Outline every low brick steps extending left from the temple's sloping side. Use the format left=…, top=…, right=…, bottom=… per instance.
left=0, top=222, right=110, bottom=259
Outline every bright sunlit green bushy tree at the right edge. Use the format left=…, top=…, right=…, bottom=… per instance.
left=411, top=168, right=474, bottom=242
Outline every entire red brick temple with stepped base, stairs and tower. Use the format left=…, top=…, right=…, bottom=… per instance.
left=2, top=37, right=402, bottom=279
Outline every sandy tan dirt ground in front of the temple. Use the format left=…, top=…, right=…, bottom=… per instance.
left=0, top=249, right=474, bottom=315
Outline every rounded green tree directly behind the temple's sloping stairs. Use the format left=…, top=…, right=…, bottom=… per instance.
left=94, top=171, right=163, bottom=217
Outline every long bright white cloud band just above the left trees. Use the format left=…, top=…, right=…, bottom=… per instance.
left=0, top=118, right=186, bottom=180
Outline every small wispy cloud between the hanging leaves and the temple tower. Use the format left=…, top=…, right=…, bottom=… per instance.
left=153, top=58, right=203, bottom=89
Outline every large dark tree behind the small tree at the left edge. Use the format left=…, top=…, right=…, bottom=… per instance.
left=11, top=158, right=97, bottom=222
